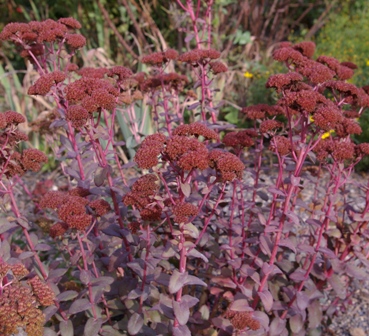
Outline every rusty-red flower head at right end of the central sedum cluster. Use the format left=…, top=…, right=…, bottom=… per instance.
left=208, top=149, right=245, bottom=182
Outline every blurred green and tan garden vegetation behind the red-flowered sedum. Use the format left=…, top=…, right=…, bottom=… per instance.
left=0, top=0, right=369, bottom=169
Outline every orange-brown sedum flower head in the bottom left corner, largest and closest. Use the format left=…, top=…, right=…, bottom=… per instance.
left=0, top=282, right=45, bottom=336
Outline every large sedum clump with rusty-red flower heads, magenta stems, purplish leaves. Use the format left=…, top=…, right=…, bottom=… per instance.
left=0, top=1, right=369, bottom=336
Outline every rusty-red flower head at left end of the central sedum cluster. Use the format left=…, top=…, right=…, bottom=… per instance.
left=134, top=133, right=166, bottom=169
